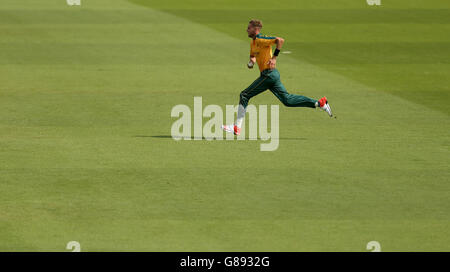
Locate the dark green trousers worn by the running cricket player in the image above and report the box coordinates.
[239,69,317,108]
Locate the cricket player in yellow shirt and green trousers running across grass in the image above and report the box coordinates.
[222,20,333,135]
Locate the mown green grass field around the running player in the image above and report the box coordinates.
[0,0,450,251]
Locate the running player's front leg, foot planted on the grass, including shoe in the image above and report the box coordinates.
[222,76,273,135]
